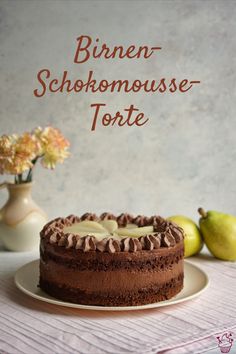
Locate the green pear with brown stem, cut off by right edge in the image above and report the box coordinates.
[198,208,236,261]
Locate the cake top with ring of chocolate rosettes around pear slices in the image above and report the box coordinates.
[41,213,184,253]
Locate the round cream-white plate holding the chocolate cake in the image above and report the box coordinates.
[15,260,209,311]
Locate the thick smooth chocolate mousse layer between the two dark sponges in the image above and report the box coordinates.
[40,261,183,294]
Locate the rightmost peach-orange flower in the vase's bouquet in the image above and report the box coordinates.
[33,127,70,169]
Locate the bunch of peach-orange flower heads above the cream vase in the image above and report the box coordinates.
[0,127,70,183]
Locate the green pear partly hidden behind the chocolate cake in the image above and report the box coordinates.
[168,215,203,258]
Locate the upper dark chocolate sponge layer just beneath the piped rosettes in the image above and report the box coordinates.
[40,242,184,270]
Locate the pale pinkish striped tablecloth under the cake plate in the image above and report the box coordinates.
[0,249,236,354]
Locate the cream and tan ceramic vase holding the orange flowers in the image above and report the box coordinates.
[0,183,47,251]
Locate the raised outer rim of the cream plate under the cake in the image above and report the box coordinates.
[14,259,210,311]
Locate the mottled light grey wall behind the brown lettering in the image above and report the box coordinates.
[0,0,236,218]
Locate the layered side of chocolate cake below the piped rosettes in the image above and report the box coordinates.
[40,243,184,306]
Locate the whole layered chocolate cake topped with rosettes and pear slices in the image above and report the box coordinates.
[39,213,184,306]
